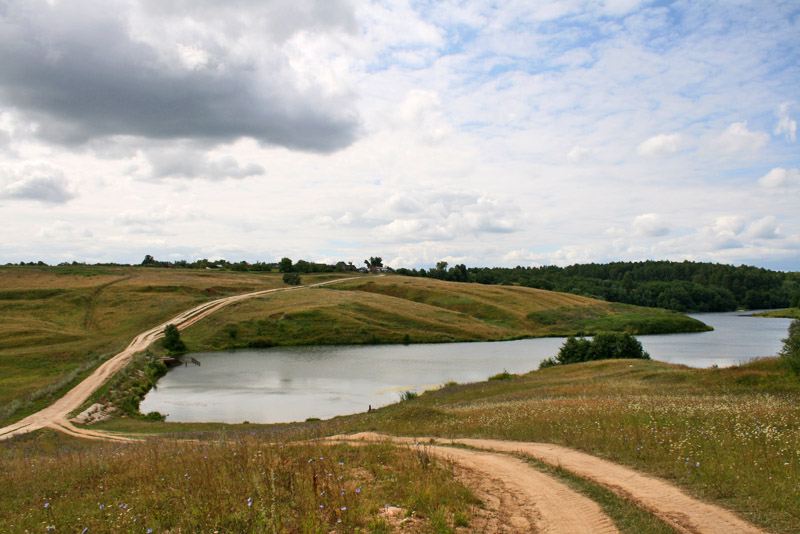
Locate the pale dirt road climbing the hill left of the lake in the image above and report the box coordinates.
[0,277,355,441]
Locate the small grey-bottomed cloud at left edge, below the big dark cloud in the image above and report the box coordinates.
[0,164,75,204]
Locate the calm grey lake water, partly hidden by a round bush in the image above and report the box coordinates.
[140,312,791,423]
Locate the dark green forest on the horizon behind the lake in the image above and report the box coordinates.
[395,261,800,312]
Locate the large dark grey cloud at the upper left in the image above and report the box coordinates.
[0,0,359,152]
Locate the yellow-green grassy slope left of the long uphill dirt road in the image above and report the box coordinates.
[0,266,348,422]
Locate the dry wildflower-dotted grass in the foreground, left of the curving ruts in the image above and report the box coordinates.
[0,433,477,533]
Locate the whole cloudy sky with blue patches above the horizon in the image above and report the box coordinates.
[0,0,800,271]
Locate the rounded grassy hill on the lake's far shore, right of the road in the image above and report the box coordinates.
[183,276,707,351]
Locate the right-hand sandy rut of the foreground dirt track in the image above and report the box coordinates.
[330,432,767,534]
